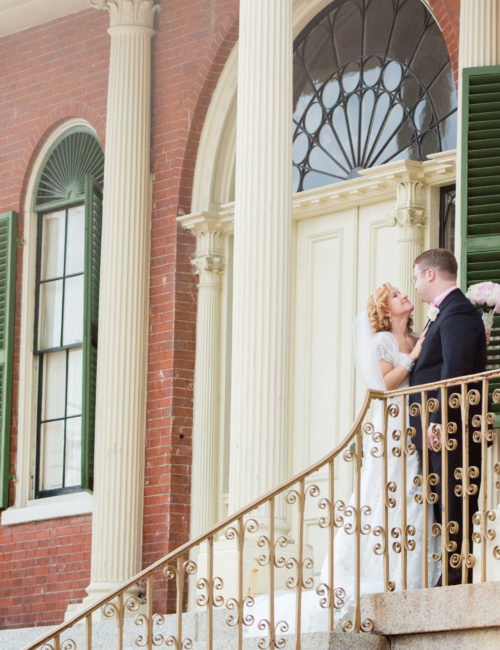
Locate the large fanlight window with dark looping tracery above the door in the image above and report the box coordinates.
[293,0,457,191]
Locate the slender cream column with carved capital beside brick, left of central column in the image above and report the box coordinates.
[191,217,224,537]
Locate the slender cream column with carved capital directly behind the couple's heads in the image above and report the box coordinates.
[396,179,427,329]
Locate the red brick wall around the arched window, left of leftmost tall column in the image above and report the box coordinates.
[0,10,109,627]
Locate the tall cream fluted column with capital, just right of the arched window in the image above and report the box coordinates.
[87,0,156,597]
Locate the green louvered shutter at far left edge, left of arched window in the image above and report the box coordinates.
[0,212,17,508]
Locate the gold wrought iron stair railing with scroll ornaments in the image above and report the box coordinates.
[26,369,500,650]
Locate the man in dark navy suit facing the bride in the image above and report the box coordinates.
[410,248,486,585]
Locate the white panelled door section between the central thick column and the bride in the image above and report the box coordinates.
[293,209,357,573]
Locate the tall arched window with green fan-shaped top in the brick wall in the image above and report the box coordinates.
[34,127,104,497]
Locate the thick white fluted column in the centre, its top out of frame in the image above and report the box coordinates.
[229,0,292,514]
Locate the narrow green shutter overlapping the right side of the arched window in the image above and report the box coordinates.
[82,176,102,490]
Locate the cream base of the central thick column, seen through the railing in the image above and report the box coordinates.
[195,538,314,604]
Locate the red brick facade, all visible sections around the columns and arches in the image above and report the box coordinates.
[0,0,459,627]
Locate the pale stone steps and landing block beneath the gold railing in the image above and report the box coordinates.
[5,582,500,650]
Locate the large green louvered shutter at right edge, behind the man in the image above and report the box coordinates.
[461,66,500,426]
